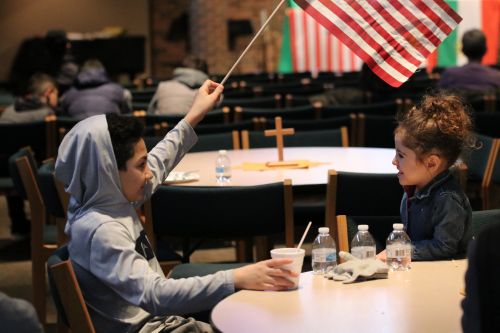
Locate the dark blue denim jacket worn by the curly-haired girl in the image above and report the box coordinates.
[401,170,472,260]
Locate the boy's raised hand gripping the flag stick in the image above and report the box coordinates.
[184,80,224,127]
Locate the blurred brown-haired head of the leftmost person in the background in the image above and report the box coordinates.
[23,73,59,108]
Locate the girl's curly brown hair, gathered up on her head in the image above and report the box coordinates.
[395,93,475,166]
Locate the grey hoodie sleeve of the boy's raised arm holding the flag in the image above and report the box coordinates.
[146,119,198,193]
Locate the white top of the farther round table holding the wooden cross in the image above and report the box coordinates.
[174,147,397,186]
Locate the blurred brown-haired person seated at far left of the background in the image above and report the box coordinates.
[0,73,59,124]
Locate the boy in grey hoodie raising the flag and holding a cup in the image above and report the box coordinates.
[55,81,298,333]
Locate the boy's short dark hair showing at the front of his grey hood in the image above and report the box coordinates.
[106,113,144,171]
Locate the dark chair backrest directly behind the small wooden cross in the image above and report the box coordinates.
[241,126,349,149]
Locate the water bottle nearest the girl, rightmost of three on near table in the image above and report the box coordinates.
[385,223,411,271]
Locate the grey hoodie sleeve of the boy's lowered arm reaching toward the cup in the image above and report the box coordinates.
[90,222,234,315]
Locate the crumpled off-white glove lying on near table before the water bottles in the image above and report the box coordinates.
[325,251,389,283]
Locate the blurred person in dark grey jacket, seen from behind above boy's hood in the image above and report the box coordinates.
[61,59,131,119]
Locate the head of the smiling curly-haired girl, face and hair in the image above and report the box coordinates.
[392,94,475,190]
